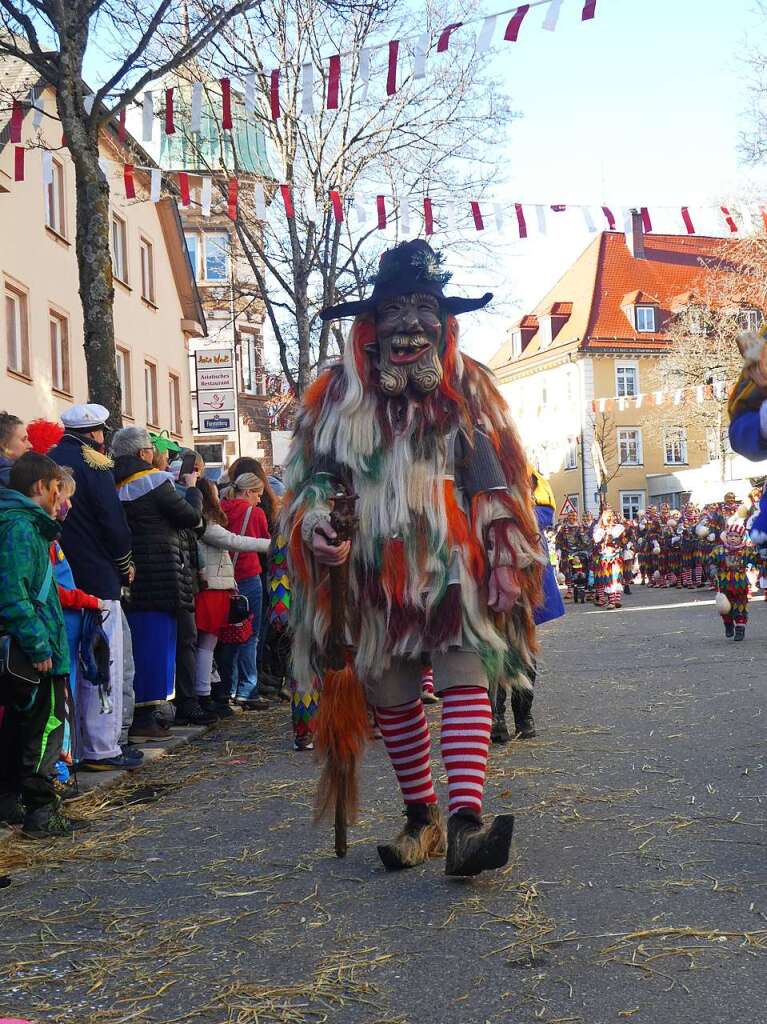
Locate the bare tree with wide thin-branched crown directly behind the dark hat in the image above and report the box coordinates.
[167,0,512,393]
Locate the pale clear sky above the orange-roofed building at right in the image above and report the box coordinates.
[445,0,767,358]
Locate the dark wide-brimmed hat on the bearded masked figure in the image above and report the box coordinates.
[319,239,493,321]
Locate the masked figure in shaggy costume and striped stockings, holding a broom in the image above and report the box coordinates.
[284,240,544,876]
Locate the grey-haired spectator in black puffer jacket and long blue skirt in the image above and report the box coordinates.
[112,427,204,735]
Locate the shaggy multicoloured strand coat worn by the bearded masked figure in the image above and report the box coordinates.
[284,315,544,686]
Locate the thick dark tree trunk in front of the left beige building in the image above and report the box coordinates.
[56,58,123,429]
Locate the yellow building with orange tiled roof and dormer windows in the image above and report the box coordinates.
[489,215,761,516]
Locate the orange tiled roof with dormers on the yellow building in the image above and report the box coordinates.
[491,231,745,370]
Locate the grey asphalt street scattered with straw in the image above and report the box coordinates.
[0,588,767,1024]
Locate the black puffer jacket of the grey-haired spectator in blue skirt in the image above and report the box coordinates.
[115,455,203,613]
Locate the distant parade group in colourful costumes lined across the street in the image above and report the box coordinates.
[553,487,767,640]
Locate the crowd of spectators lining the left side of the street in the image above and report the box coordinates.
[0,404,290,839]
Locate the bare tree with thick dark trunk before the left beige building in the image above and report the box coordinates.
[0,0,254,423]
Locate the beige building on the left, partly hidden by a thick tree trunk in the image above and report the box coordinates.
[0,60,205,443]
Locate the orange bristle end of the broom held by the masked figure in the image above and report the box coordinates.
[314,662,368,857]
